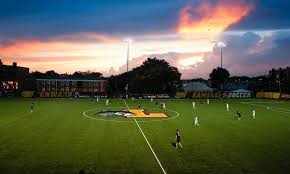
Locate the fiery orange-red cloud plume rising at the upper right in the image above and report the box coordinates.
[177,0,253,33]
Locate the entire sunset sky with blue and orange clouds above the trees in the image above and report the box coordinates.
[0,0,290,79]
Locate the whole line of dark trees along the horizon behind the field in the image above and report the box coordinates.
[29,57,290,94]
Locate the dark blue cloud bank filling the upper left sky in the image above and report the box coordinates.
[0,0,181,38]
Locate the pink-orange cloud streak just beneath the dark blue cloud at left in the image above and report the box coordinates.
[0,33,119,56]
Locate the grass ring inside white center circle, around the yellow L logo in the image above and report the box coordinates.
[82,107,179,123]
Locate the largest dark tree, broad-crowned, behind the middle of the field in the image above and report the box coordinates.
[109,57,181,94]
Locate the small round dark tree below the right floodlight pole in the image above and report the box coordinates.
[209,67,230,90]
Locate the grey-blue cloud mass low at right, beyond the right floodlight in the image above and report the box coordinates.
[218,32,290,75]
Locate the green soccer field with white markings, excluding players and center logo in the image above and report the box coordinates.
[0,99,290,174]
